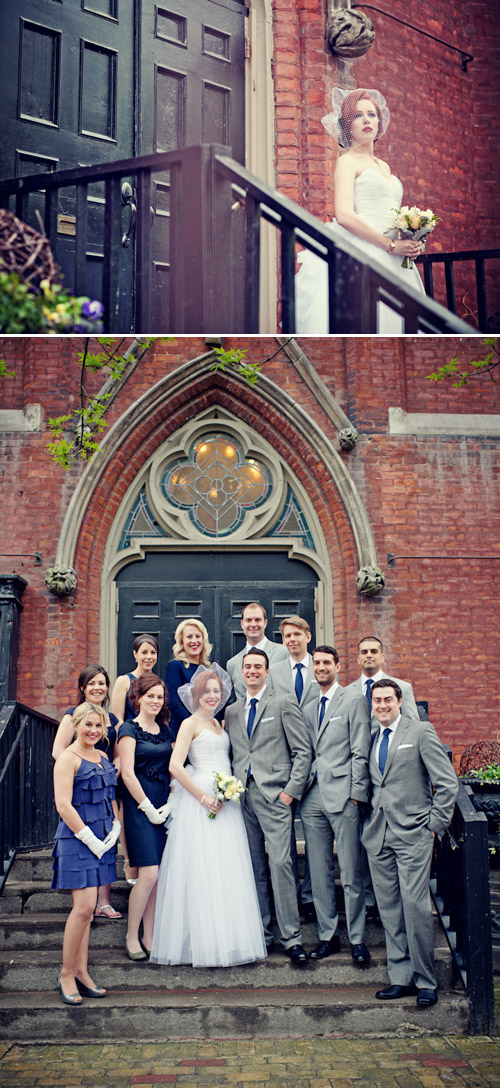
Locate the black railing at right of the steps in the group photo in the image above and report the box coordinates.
[430,783,495,1035]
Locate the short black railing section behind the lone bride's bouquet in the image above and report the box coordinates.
[418,249,500,333]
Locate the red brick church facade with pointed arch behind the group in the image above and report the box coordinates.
[0,337,500,757]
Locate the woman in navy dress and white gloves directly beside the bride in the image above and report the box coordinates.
[118,673,173,960]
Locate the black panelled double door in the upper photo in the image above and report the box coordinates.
[0,0,248,332]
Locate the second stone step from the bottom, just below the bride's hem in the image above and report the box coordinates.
[0,932,452,993]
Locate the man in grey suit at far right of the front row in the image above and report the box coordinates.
[362,679,459,1007]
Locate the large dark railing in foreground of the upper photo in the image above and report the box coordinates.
[0,146,475,334]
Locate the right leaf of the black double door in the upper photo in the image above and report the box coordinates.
[138,0,248,332]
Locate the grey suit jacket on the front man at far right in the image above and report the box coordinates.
[361,717,459,854]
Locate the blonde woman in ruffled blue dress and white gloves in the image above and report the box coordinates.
[52,703,120,1005]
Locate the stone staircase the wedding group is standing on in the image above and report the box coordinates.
[0,850,468,1042]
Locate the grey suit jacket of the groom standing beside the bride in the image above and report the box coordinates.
[225,688,312,802]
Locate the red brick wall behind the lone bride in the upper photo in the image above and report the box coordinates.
[274,0,500,317]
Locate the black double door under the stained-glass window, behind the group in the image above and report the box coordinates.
[116,552,317,676]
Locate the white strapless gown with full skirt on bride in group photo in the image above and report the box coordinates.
[151,729,267,967]
